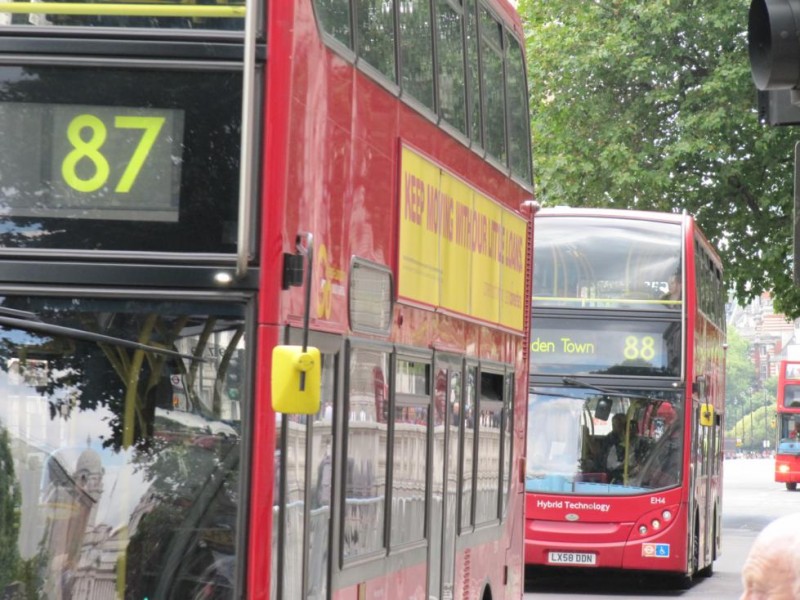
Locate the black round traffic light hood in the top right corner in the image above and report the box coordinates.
[747,0,800,91]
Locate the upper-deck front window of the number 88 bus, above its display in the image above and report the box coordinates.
[533,216,682,310]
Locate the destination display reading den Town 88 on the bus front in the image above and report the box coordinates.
[531,319,680,376]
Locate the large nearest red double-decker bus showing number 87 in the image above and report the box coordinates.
[0,0,532,600]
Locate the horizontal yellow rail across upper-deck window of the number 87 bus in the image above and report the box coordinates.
[0,0,244,17]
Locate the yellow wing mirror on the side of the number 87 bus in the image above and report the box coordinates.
[272,346,322,415]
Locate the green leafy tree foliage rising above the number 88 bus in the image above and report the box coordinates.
[519,0,800,317]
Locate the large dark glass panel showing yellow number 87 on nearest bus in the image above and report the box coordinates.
[0,64,242,253]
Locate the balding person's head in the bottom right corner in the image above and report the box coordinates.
[740,513,800,600]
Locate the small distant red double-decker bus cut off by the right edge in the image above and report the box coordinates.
[775,360,800,491]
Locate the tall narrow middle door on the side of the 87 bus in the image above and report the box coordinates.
[428,361,463,600]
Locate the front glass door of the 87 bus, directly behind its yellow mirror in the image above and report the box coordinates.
[272,331,341,600]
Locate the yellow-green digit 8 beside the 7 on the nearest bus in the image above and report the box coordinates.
[61,115,109,192]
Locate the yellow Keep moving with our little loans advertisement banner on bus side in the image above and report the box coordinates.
[398,146,527,332]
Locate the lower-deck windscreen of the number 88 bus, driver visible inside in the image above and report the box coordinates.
[525,387,684,495]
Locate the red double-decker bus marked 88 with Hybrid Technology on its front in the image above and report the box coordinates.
[525,208,725,584]
